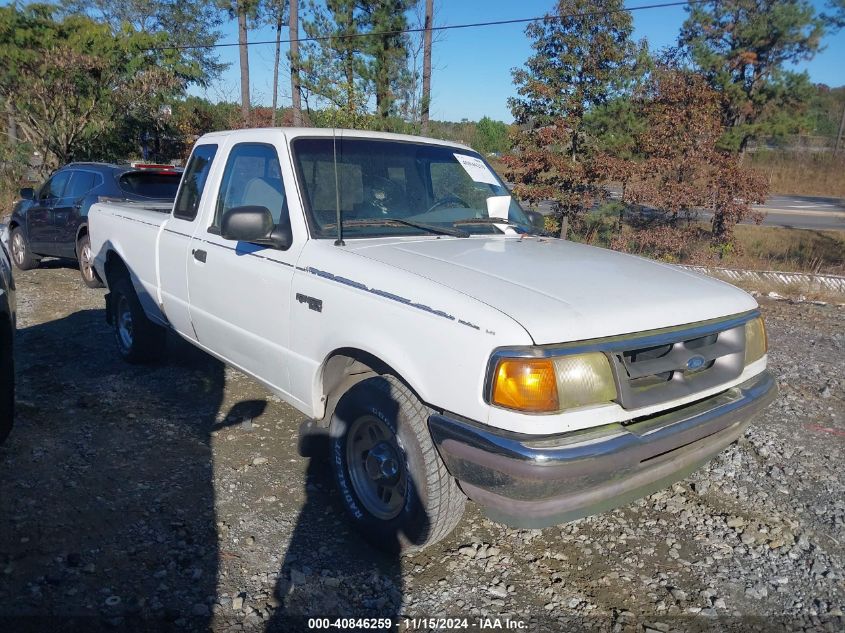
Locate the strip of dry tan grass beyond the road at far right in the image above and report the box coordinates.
[746,151,845,198]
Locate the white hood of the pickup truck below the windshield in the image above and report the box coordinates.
[347,236,757,345]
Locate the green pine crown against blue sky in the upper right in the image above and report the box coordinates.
[679,0,824,151]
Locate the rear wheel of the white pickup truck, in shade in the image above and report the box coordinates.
[109,275,167,364]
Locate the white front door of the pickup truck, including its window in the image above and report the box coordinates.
[188,135,304,393]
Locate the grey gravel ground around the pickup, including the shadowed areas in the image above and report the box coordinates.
[0,262,845,631]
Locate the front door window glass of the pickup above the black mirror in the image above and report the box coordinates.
[212,143,287,229]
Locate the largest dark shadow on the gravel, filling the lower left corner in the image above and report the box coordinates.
[0,310,244,631]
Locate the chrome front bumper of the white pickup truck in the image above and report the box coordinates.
[429,372,777,528]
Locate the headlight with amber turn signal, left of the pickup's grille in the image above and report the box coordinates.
[490,352,616,413]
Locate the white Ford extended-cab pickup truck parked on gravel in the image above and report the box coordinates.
[90,128,776,548]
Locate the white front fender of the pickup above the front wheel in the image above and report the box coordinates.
[290,242,531,421]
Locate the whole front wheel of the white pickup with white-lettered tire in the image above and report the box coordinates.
[330,375,466,552]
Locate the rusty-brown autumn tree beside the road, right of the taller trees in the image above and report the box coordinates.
[605,67,767,259]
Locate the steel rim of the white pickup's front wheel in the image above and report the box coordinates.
[346,415,408,521]
